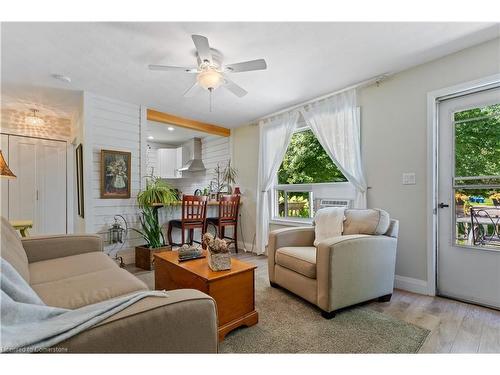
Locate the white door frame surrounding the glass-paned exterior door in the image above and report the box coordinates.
[427,73,500,296]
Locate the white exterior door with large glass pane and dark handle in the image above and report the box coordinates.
[437,88,500,308]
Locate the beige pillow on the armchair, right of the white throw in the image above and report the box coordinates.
[342,208,391,235]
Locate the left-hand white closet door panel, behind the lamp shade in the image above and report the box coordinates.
[9,136,38,234]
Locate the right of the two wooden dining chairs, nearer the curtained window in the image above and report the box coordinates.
[205,195,240,252]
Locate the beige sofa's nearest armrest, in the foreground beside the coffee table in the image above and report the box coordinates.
[56,289,218,353]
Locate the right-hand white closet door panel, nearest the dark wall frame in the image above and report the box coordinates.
[36,140,66,234]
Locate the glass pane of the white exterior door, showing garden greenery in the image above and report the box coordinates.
[453,104,500,250]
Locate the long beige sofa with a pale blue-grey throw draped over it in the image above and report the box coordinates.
[1,218,218,353]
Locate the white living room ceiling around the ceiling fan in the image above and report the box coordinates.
[1,22,499,127]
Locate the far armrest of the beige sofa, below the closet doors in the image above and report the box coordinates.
[21,234,102,263]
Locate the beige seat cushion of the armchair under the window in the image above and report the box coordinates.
[276,246,316,279]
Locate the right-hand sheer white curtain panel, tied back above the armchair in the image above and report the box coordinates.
[301,89,366,208]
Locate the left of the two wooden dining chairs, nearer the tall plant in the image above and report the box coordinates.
[167,195,208,246]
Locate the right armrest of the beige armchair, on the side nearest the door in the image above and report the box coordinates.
[316,234,397,312]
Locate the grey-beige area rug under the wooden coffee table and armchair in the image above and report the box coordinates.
[137,272,429,353]
